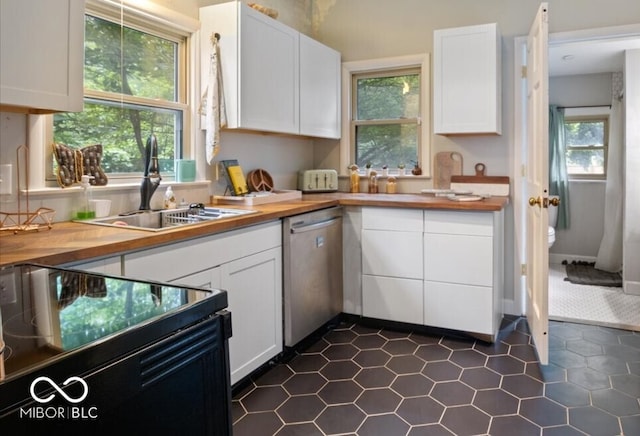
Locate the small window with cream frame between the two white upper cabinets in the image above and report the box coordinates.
[341,55,430,176]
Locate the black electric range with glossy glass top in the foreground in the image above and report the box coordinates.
[0,264,231,434]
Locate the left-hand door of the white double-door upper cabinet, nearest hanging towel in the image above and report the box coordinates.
[240,4,300,134]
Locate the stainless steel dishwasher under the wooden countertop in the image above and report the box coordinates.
[283,207,342,347]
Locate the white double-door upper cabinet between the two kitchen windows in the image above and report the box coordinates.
[200,2,340,138]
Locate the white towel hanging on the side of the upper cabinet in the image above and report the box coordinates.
[200,33,227,165]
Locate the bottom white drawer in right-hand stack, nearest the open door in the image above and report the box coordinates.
[424,281,494,334]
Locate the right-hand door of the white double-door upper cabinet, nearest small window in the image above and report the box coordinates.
[300,34,340,138]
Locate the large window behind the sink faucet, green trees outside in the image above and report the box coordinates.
[48,9,187,183]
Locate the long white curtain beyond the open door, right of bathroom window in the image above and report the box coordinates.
[595,73,624,272]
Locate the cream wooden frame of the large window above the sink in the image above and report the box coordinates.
[41,0,200,187]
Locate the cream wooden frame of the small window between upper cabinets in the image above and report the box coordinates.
[339,53,431,177]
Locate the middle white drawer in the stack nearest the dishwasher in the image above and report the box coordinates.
[362,230,423,280]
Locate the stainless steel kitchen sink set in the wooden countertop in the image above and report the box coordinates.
[77,207,258,232]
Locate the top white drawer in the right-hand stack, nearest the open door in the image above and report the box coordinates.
[424,210,493,236]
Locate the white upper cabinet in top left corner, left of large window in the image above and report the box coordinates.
[0,0,84,113]
